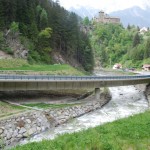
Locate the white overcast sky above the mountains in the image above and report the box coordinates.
[59,0,150,13]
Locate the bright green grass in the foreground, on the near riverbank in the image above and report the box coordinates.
[13,111,150,150]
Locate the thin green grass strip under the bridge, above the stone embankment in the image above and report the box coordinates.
[23,103,78,109]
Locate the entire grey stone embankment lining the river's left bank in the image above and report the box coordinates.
[0,91,111,147]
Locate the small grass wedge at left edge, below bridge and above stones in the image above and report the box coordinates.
[0,101,25,118]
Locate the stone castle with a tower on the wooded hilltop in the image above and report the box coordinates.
[94,11,120,23]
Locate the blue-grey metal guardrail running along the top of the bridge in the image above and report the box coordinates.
[0,75,150,81]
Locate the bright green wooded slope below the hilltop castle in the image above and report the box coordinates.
[90,23,150,68]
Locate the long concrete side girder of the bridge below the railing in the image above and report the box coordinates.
[0,78,150,91]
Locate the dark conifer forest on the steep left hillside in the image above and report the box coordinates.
[0,0,94,71]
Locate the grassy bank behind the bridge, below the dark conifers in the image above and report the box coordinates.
[0,59,84,75]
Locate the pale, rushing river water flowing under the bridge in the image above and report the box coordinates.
[22,83,148,144]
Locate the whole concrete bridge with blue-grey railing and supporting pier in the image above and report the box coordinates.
[0,75,150,97]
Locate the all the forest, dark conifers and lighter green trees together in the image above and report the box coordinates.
[0,0,150,71]
